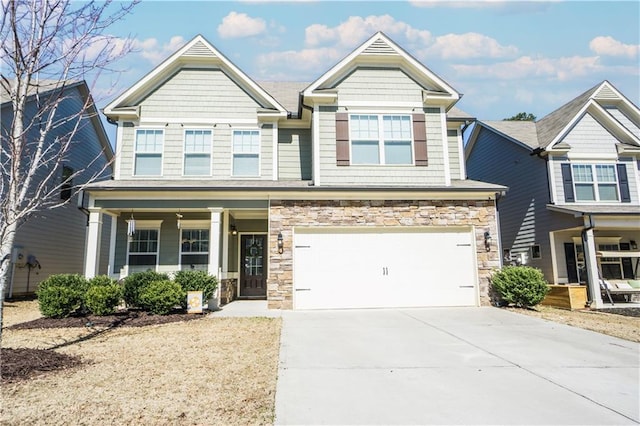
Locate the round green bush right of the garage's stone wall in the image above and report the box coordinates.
[491,266,549,307]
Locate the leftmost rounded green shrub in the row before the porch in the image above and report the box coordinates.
[36,274,89,318]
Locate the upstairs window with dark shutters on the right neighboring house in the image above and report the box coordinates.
[573,164,619,201]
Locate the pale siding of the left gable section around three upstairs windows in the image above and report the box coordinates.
[119,69,275,180]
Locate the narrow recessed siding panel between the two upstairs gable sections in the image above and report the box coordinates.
[278,129,312,180]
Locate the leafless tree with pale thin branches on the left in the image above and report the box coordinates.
[0,0,137,342]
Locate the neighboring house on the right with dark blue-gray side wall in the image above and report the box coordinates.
[465,81,640,305]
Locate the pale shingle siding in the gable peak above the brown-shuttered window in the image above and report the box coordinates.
[332,68,422,104]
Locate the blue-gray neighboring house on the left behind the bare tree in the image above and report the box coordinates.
[1,81,113,297]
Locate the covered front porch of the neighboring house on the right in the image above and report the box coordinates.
[550,206,640,309]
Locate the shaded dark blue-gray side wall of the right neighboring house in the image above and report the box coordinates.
[466,129,581,281]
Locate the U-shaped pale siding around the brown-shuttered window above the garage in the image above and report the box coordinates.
[319,107,445,185]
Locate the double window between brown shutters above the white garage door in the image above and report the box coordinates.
[349,114,413,164]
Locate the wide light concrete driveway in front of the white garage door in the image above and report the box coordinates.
[276,308,640,425]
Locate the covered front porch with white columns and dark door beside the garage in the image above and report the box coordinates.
[85,197,269,303]
